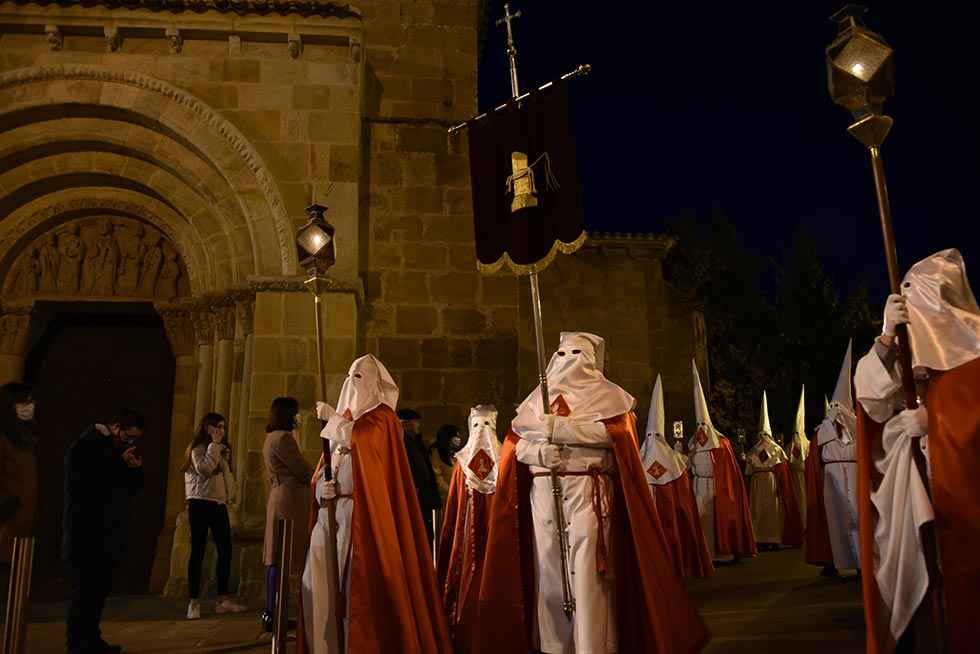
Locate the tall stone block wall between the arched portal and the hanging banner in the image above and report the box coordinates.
[359,1,518,436]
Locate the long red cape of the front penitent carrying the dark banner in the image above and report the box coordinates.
[474,412,708,654]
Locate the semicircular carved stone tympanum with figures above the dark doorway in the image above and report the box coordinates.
[4,217,189,300]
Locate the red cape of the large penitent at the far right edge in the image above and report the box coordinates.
[858,359,980,654]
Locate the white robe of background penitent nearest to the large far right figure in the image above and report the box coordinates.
[820,438,861,570]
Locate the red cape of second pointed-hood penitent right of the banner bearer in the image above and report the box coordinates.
[711,434,756,556]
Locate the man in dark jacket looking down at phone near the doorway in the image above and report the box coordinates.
[62,409,143,654]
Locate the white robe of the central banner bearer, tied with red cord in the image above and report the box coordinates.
[518,422,617,654]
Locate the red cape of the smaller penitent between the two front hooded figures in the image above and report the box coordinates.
[436,462,493,654]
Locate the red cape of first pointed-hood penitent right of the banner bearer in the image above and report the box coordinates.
[651,471,715,578]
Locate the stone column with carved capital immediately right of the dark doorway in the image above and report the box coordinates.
[151,304,197,597]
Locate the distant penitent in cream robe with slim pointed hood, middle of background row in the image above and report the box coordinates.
[745,391,803,547]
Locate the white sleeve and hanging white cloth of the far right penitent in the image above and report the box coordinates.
[854,349,935,637]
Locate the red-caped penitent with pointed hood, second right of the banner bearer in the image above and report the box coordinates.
[687,361,756,561]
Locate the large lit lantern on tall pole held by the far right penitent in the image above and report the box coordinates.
[826,4,945,652]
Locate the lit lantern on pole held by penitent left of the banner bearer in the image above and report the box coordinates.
[296,203,344,648]
